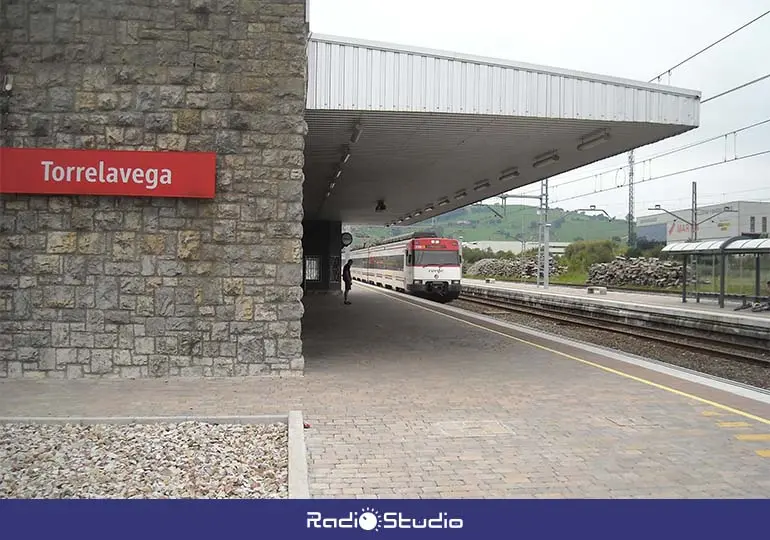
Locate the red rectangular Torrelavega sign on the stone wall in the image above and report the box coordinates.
[0,148,216,199]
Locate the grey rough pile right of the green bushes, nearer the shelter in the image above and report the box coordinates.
[586,257,680,288]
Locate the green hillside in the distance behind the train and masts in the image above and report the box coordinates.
[351,205,628,246]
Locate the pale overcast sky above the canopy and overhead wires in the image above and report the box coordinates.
[308,0,770,218]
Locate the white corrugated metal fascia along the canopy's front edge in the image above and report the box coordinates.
[307,37,700,126]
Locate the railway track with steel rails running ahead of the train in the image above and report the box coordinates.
[459,294,770,367]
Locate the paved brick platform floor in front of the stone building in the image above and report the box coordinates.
[0,283,770,498]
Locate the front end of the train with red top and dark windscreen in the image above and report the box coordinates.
[407,238,462,302]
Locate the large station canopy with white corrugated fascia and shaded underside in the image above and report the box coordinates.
[304,36,700,225]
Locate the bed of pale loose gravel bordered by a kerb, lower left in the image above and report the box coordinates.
[0,422,289,499]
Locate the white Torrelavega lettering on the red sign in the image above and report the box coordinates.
[40,161,171,189]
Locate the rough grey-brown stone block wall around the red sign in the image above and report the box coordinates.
[0,0,307,378]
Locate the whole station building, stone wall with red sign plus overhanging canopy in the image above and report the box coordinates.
[0,0,700,378]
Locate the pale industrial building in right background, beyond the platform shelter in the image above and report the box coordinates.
[636,201,770,243]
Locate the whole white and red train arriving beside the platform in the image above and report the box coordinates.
[349,232,462,302]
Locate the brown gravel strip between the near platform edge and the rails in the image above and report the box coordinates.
[452,300,770,390]
